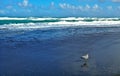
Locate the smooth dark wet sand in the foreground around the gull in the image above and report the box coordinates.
[0,28,120,76]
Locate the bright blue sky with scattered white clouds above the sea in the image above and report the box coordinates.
[0,0,120,17]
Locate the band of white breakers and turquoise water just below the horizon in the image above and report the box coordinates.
[0,17,120,30]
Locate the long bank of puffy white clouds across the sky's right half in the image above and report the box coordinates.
[59,3,120,12]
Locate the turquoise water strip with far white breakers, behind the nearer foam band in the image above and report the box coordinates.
[0,17,120,25]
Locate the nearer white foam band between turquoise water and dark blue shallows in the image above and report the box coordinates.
[0,21,120,30]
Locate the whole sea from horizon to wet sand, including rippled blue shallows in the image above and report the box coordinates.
[0,17,120,41]
